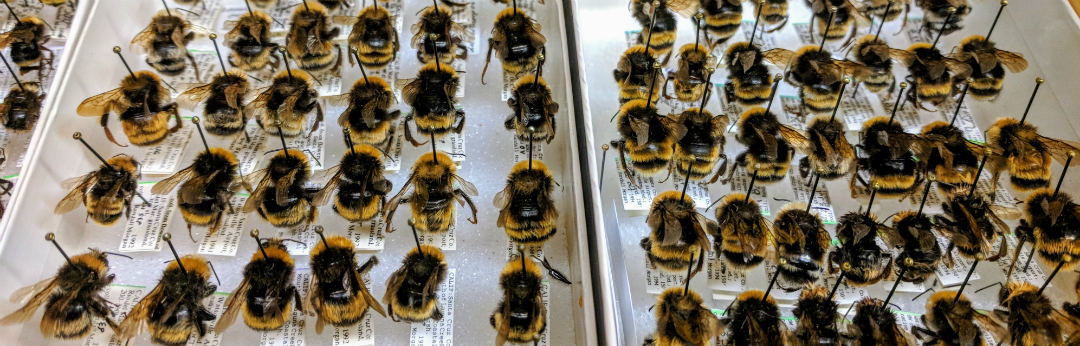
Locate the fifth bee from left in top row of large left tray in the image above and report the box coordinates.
[411,5,475,65]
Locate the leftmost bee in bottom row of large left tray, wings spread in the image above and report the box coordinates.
[0,232,118,340]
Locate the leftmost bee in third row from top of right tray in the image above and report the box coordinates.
[611,99,679,186]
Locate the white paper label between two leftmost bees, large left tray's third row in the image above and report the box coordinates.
[119,183,176,252]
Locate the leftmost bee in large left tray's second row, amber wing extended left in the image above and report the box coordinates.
[76,46,184,147]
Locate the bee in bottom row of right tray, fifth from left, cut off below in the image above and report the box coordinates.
[912,291,1002,346]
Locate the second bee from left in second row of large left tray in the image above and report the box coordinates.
[176,69,252,136]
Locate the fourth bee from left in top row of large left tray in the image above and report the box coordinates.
[335,4,401,69]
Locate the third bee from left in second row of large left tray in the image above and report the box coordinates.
[245,51,323,137]
